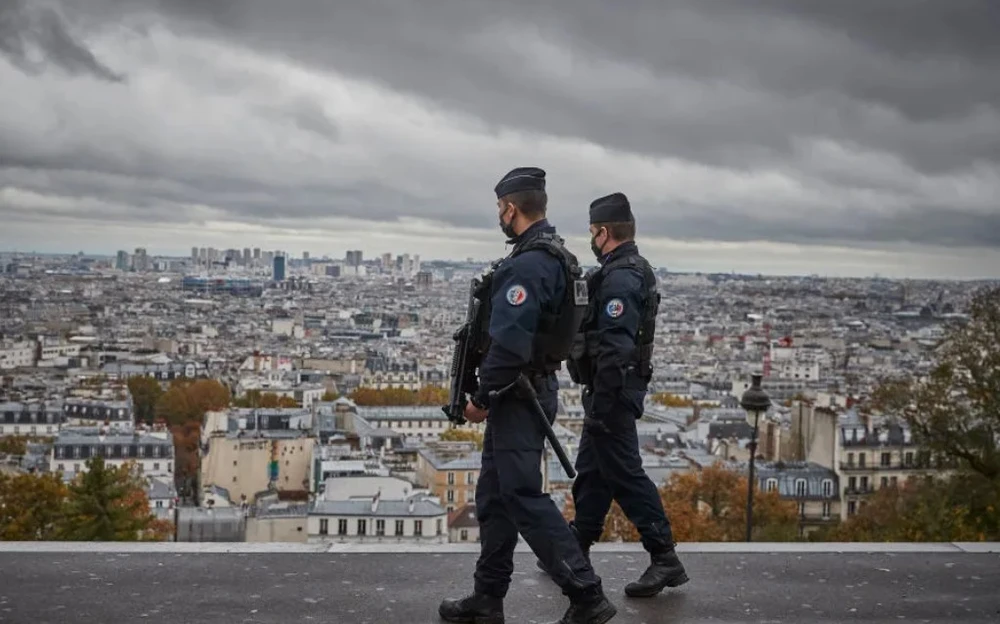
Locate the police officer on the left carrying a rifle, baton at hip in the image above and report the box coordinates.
[439,167,616,624]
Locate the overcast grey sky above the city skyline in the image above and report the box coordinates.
[0,0,1000,277]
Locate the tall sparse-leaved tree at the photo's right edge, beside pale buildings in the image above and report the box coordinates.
[871,287,1000,480]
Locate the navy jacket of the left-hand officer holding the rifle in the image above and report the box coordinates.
[475,219,566,405]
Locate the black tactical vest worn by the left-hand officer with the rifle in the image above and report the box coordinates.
[476,232,589,373]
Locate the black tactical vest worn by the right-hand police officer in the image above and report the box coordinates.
[567,254,660,386]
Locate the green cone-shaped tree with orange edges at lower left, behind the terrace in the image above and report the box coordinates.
[60,456,162,542]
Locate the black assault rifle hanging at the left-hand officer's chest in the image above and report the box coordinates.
[441,277,488,425]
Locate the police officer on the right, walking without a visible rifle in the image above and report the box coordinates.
[538,193,688,597]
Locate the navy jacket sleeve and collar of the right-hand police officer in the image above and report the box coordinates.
[590,241,645,417]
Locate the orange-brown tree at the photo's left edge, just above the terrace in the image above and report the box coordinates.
[0,473,69,541]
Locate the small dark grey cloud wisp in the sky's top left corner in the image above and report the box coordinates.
[0,0,125,82]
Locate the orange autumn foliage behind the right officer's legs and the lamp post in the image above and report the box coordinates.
[566,464,798,542]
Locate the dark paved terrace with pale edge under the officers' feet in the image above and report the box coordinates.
[0,542,1000,624]
